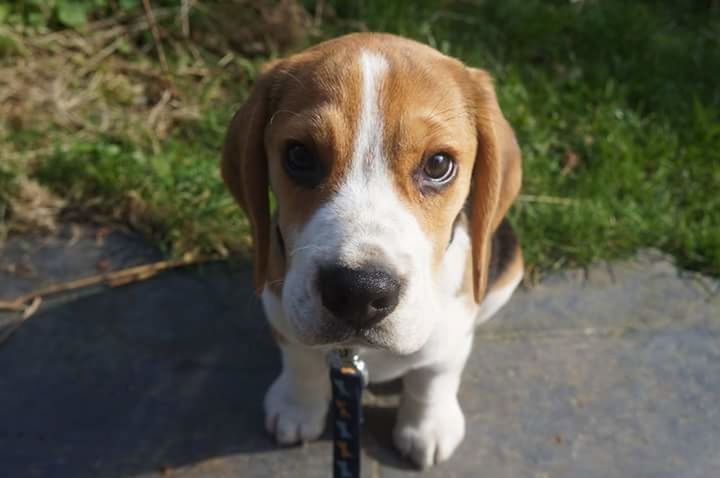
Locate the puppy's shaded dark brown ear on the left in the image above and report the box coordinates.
[221,64,275,293]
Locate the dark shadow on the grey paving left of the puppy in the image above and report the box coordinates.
[0,264,286,477]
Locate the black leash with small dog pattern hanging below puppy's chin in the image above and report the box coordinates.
[329,349,368,478]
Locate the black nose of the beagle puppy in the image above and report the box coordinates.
[318,266,401,329]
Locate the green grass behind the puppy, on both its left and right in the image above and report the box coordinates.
[0,0,720,275]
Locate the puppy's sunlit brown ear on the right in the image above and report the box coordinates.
[468,68,522,303]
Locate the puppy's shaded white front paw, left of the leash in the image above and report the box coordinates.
[265,375,328,445]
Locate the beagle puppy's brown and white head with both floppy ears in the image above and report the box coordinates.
[222,34,520,353]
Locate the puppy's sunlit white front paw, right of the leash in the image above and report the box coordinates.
[393,400,465,468]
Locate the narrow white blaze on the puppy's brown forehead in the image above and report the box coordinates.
[350,50,388,177]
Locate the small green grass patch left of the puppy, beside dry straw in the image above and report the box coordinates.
[35,121,248,255]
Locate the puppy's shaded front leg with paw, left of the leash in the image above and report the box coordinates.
[265,343,330,445]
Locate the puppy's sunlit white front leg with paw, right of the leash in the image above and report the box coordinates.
[394,336,472,468]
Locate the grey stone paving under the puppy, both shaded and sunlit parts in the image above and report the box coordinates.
[0,228,720,478]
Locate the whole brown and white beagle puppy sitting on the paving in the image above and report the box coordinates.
[221,33,523,467]
